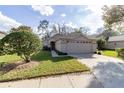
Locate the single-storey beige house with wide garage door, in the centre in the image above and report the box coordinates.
[43,32,97,53]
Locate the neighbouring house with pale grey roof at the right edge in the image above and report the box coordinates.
[106,35,124,49]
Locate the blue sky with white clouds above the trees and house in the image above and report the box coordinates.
[0,5,104,33]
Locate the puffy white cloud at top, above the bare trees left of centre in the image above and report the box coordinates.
[32,5,54,16]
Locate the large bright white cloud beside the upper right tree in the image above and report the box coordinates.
[80,5,103,33]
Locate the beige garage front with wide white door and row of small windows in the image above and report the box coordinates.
[56,38,97,53]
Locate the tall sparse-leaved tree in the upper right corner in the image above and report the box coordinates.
[102,5,124,31]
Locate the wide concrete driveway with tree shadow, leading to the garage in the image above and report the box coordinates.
[71,54,124,88]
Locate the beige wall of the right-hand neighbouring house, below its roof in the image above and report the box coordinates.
[106,41,124,49]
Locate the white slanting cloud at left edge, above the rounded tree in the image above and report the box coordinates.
[0,12,21,31]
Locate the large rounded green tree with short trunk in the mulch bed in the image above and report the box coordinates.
[1,31,41,62]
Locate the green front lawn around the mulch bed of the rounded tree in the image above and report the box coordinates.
[0,51,89,81]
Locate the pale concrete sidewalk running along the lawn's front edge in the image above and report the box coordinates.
[0,73,103,88]
